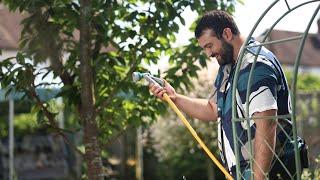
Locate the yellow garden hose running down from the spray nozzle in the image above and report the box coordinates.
[163,93,233,180]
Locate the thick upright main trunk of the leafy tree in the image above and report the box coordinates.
[79,0,104,180]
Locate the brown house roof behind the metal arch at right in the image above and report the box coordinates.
[260,30,320,67]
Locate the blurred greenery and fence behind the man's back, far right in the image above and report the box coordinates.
[286,72,320,177]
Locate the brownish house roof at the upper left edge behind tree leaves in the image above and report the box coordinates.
[0,5,24,50]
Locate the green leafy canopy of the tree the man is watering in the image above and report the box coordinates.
[0,0,239,178]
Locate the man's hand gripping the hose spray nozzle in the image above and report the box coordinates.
[149,80,177,101]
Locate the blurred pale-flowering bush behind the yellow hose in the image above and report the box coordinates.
[149,115,219,179]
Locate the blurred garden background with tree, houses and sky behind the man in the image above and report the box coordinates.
[0,0,320,180]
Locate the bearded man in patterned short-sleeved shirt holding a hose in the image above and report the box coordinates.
[150,10,308,179]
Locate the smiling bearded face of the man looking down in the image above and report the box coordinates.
[198,30,234,66]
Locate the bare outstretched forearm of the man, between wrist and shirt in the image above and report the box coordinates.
[174,94,217,121]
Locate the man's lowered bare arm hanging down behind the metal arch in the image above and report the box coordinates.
[253,110,277,180]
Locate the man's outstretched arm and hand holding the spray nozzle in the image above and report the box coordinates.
[149,82,217,121]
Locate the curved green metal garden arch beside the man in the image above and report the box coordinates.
[232,0,320,179]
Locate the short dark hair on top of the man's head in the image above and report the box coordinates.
[195,10,240,39]
